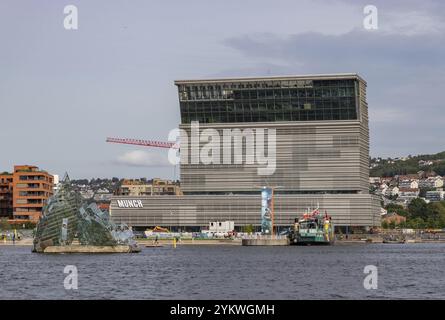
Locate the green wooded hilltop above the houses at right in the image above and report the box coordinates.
[369,151,445,177]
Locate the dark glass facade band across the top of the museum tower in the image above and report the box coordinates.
[178,79,358,124]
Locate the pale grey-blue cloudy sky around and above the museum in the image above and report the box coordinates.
[0,0,445,179]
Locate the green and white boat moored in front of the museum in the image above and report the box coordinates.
[289,208,335,245]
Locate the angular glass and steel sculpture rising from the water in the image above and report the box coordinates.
[33,175,137,252]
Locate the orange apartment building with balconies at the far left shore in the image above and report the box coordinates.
[0,165,54,222]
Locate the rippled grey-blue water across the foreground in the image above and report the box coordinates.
[0,244,445,299]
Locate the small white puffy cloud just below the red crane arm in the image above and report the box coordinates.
[114,150,171,167]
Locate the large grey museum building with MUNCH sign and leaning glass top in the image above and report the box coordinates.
[110,74,380,231]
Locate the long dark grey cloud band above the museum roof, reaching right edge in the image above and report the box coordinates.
[224,29,445,70]
